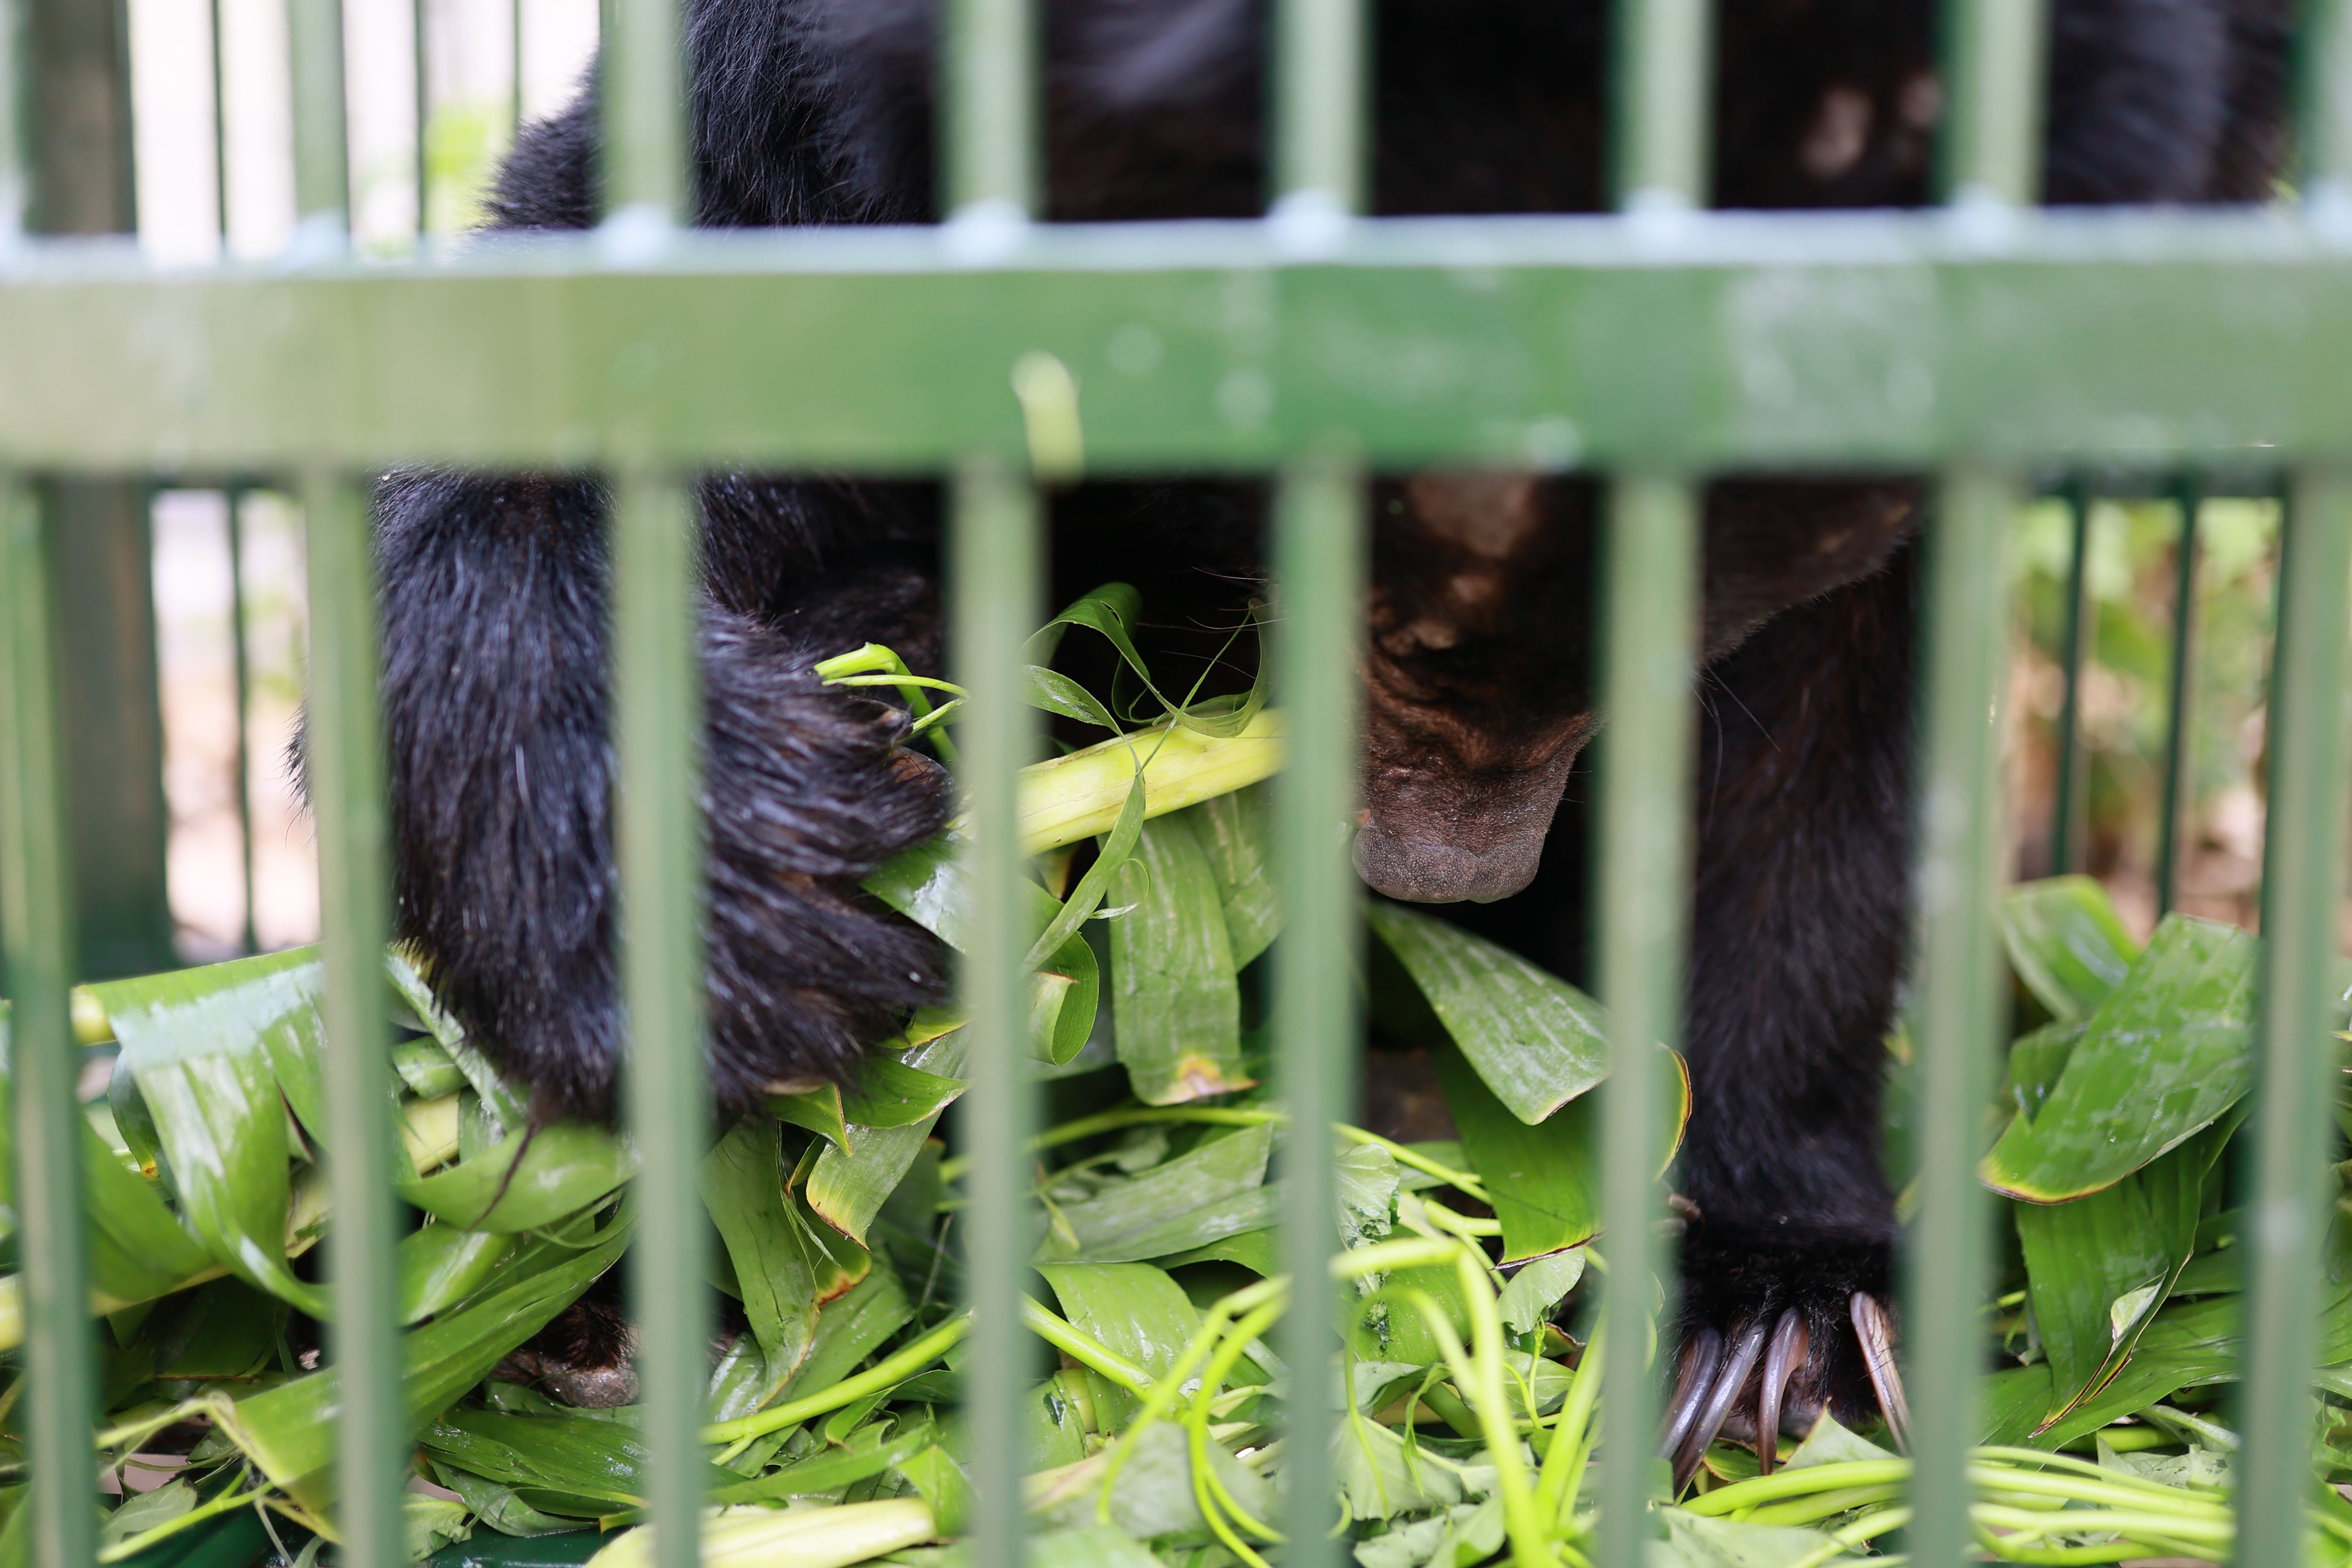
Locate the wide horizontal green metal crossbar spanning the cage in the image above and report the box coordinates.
[0,214,2352,475]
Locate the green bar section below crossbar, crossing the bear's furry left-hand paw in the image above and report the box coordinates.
[612,470,710,1568]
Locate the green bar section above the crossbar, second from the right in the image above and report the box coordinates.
[1938,0,2049,207]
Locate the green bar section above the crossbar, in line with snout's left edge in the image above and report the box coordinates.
[1272,0,1367,214]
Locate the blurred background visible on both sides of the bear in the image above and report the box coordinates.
[78,0,2296,976]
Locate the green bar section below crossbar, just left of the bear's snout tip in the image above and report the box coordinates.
[1272,451,1369,1568]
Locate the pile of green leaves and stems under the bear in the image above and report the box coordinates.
[0,595,2352,1568]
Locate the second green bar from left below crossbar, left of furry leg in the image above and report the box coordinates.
[303,472,409,1568]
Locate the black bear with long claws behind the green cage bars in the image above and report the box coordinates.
[379,0,2286,1457]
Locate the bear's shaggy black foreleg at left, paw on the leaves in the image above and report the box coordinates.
[379,475,948,1122]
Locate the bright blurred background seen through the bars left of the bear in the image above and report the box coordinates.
[101,0,597,976]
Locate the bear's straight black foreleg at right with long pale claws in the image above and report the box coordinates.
[1665,548,1915,1488]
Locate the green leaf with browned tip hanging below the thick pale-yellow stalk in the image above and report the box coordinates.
[1110,813,1251,1105]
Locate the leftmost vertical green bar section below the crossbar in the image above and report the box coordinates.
[0,470,99,1566]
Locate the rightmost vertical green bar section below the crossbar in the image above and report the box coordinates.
[2237,470,2352,1568]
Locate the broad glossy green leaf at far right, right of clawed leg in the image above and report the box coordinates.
[1983,915,2253,1203]
